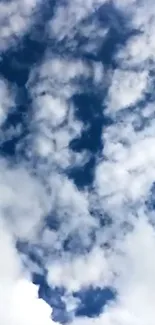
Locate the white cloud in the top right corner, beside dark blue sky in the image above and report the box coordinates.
[116,0,155,69]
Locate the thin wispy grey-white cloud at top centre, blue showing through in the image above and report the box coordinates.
[47,0,109,59]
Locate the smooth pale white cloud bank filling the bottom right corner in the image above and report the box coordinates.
[70,217,155,325]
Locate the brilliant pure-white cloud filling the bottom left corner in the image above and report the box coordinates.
[0,214,56,325]
